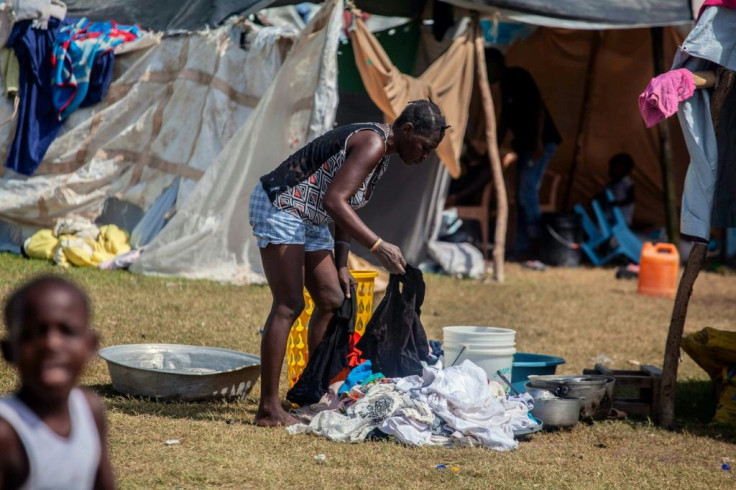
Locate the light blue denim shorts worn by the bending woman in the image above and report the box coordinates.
[248,182,335,252]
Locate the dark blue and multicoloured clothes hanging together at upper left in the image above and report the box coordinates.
[0,0,145,175]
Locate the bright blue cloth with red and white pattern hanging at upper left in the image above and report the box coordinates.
[51,19,142,120]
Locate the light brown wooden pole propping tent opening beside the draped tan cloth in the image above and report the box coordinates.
[473,19,509,282]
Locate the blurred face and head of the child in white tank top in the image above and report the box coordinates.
[1,285,97,398]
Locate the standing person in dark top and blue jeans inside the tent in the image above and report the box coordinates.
[486,49,562,269]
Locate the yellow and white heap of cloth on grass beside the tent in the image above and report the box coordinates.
[23,219,137,269]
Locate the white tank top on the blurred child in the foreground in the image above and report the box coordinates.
[0,388,101,490]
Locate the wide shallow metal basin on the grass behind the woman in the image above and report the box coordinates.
[100,344,261,401]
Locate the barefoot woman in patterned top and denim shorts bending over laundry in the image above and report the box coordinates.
[249,100,448,426]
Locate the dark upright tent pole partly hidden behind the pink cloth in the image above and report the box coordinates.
[650,27,680,245]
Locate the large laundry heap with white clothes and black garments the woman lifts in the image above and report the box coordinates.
[287,266,540,451]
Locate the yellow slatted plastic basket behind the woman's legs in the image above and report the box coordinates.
[286,271,378,388]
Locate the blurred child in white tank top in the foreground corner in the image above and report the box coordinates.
[0,276,115,489]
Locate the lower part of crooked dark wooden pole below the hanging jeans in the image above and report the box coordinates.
[659,242,708,427]
